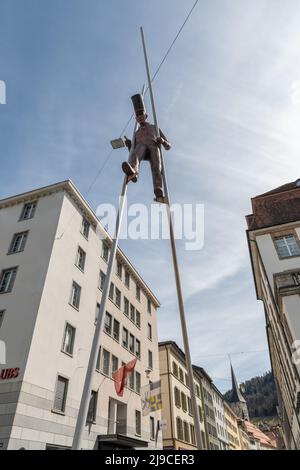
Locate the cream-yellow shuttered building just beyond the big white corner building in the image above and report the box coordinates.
[159,341,207,450]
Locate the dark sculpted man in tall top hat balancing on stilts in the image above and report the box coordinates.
[122,94,171,203]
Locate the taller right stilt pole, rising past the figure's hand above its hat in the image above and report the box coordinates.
[141,27,203,450]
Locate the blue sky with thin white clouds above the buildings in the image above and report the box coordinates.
[0,0,300,391]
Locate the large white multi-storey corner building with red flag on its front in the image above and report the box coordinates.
[0,181,162,449]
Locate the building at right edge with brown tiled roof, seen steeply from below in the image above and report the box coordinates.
[247,180,300,450]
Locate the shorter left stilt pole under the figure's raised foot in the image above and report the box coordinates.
[72,91,145,450]
